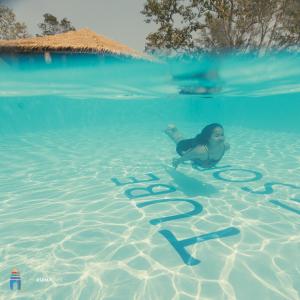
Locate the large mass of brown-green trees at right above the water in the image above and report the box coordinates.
[141,0,300,52]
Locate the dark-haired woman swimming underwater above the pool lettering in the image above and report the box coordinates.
[165,123,230,168]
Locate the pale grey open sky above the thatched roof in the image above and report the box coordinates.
[0,0,156,51]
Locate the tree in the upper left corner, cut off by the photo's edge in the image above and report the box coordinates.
[0,5,29,40]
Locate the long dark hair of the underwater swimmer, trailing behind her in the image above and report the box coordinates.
[176,123,223,155]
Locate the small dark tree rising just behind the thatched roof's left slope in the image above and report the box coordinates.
[38,13,75,36]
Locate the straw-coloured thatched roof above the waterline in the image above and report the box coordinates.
[0,28,145,57]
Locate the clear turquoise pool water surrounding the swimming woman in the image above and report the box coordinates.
[0,54,300,300]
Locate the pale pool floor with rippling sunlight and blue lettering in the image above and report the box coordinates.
[0,124,300,300]
